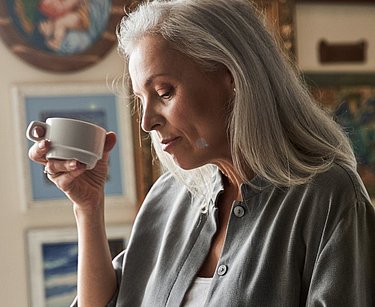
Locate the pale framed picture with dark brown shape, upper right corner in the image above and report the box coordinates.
[295,0,375,73]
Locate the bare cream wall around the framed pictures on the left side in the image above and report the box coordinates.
[0,40,134,307]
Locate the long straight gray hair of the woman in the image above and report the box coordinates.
[118,0,356,200]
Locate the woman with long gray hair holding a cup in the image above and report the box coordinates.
[30,0,375,307]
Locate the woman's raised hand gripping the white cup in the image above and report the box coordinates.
[29,127,116,211]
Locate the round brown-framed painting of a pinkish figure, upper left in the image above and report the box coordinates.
[0,0,133,72]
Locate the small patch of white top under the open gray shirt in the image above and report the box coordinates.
[182,277,212,307]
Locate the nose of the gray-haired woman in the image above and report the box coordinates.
[141,100,165,132]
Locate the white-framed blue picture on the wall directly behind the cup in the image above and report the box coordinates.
[13,82,136,209]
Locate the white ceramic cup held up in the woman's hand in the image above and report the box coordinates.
[26,117,106,169]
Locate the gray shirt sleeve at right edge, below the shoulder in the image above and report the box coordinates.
[306,202,375,307]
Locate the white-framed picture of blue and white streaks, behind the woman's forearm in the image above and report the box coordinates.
[27,226,131,307]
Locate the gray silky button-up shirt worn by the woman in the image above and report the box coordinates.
[76,164,375,307]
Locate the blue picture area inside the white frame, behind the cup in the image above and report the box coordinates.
[25,94,125,201]
